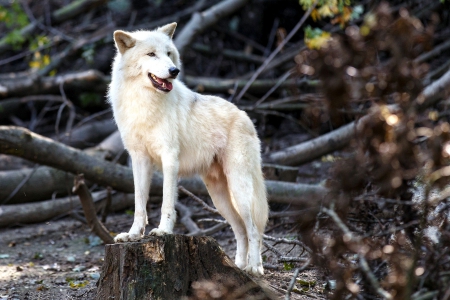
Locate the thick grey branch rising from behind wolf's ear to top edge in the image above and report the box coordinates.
[174,0,248,57]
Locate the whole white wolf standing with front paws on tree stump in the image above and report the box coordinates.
[108,23,268,275]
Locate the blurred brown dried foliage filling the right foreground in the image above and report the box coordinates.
[297,3,450,299]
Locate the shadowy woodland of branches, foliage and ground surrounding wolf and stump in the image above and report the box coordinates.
[0,0,450,300]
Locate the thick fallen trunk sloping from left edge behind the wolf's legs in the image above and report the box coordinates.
[0,126,328,207]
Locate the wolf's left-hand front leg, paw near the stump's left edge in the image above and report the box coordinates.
[114,151,153,243]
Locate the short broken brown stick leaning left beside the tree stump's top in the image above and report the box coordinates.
[72,174,114,244]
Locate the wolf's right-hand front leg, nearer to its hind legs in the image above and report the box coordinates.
[150,153,179,236]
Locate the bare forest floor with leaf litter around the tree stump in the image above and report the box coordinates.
[0,214,323,300]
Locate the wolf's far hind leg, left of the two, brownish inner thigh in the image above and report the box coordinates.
[203,163,248,269]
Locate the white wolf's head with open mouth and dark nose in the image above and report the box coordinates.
[114,23,181,93]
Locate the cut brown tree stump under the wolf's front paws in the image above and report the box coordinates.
[96,235,272,300]
